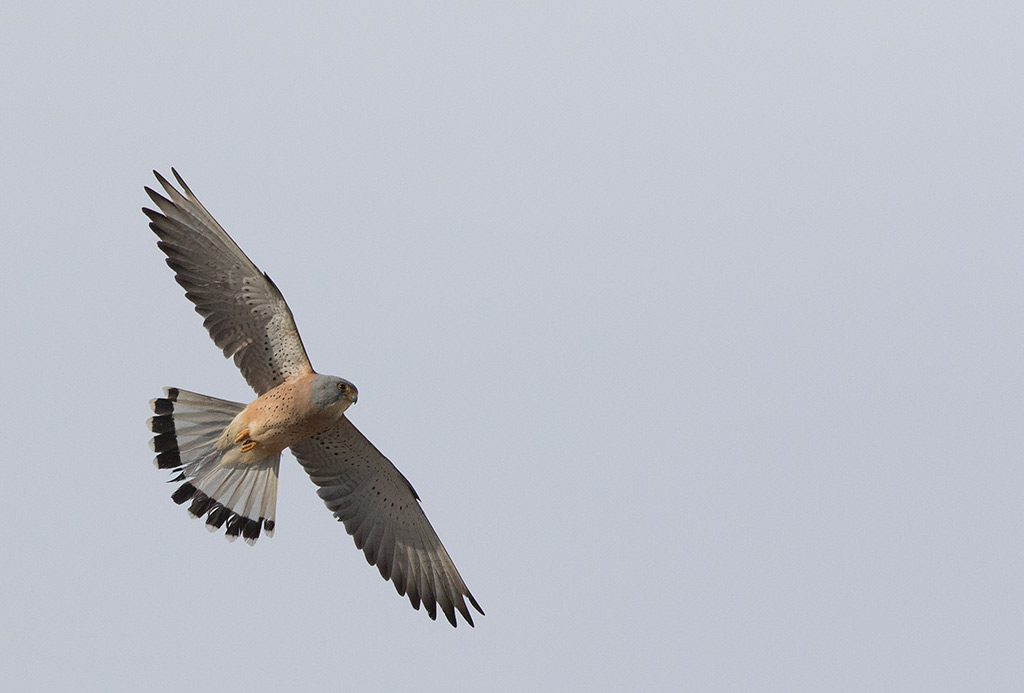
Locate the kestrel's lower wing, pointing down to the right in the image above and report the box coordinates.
[292,418,483,625]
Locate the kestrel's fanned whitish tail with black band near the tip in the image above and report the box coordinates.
[148,388,281,544]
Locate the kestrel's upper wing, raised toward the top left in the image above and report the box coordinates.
[142,169,312,394]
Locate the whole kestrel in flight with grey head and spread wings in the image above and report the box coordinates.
[142,169,483,625]
